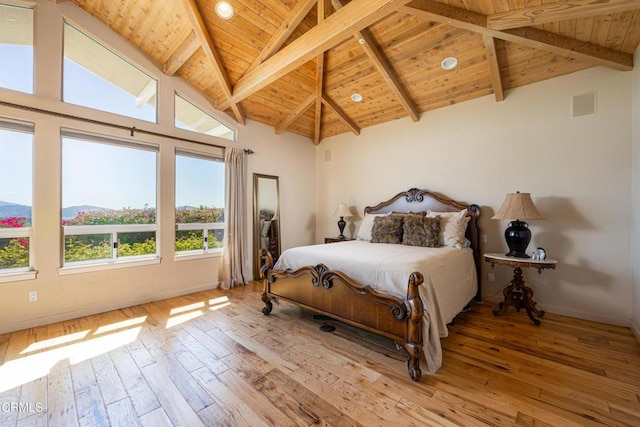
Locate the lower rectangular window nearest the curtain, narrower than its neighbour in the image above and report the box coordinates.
[176,151,224,254]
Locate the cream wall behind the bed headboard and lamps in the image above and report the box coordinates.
[316,68,632,325]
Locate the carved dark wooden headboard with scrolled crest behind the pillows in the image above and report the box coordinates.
[364,188,482,302]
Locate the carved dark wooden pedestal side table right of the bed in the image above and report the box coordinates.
[484,253,558,326]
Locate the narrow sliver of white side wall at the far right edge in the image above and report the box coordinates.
[631,48,640,340]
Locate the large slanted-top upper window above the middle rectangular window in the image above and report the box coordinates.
[62,22,157,122]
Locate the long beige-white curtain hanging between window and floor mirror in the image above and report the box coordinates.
[221,148,247,289]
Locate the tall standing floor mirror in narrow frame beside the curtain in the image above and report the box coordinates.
[253,173,280,279]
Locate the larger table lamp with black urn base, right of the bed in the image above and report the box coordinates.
[491,191,546,258]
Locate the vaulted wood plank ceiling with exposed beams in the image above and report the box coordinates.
[73,0,640,144]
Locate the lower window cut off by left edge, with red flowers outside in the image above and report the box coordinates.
[0,121,33,274]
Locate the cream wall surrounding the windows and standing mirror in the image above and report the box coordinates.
[0,0,315,333]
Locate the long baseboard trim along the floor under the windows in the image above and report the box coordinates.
[0,282,220,334]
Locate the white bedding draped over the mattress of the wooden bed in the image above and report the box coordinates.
[275,240,478,373]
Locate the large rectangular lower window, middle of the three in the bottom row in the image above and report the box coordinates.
[62,131,158,265]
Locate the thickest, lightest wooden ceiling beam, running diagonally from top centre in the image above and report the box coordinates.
[226,0,416,108]
